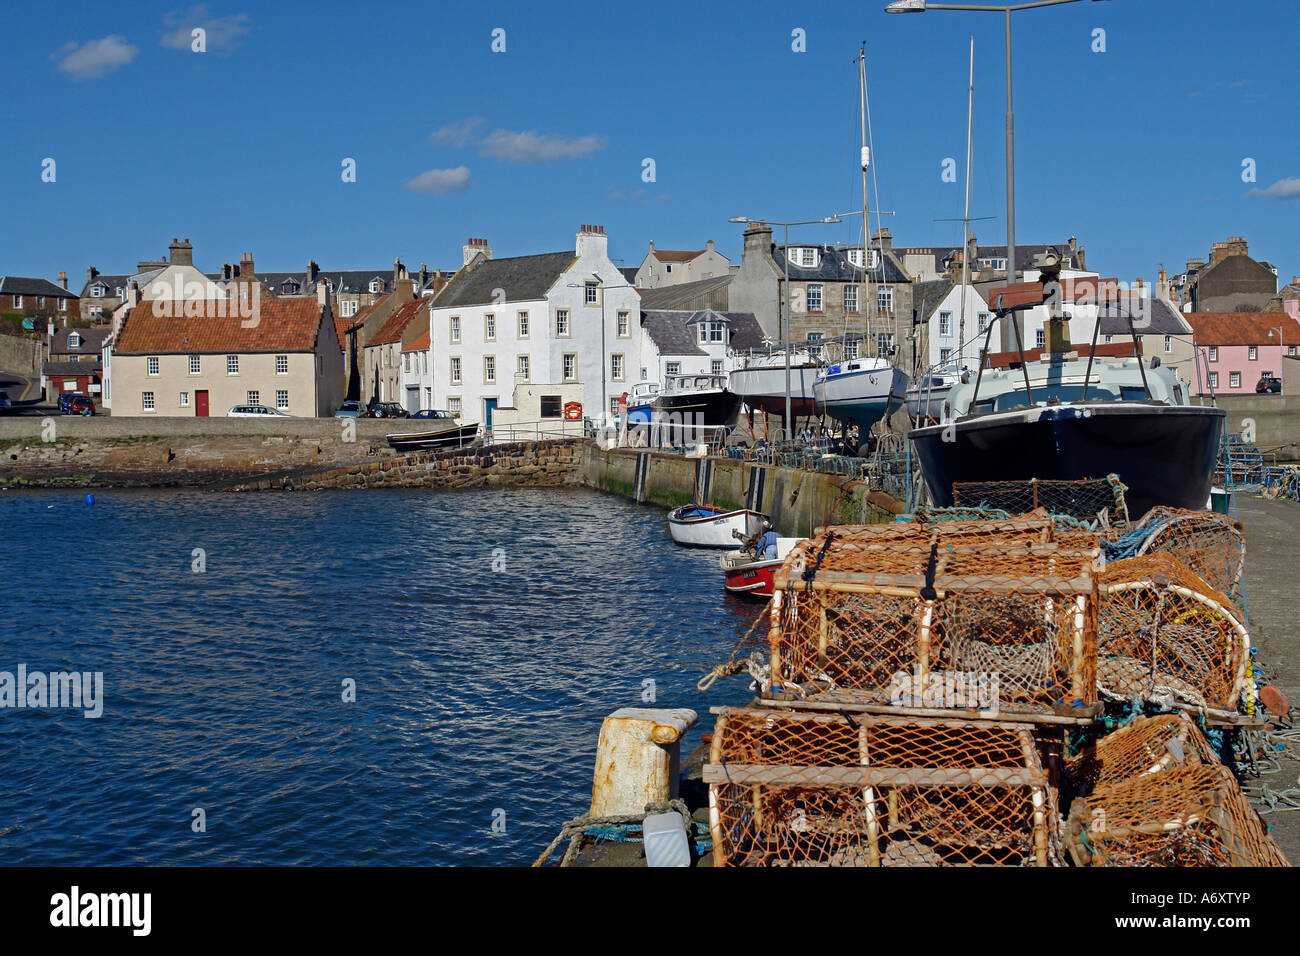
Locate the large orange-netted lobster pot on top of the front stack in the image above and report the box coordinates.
[768,523,1100,711]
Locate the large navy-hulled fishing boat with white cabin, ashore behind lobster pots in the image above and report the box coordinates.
[910,265,1225,518]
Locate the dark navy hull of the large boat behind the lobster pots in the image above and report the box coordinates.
[909,402,1225,520]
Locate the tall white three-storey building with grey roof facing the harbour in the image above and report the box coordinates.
[429,225,649,428]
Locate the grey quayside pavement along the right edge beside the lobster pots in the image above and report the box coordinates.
[1236,494,1300,865]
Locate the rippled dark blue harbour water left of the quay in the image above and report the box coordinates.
[0,489,758,865]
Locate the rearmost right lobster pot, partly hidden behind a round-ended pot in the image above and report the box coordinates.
[1135,506,1245,607]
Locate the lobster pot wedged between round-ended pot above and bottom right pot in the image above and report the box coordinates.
[1065,714,1219,792]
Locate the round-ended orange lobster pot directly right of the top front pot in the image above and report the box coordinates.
[1097,554,1251,713]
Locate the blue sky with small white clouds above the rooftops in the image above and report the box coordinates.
[0,0,1300,287]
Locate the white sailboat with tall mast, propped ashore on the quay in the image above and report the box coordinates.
[813,47,907,438]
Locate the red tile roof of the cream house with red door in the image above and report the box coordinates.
[113,297,321,355]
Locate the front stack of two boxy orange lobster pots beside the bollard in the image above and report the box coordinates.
[705,514,1102,866]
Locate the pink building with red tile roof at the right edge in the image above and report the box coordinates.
[1183,312,1300,395]
